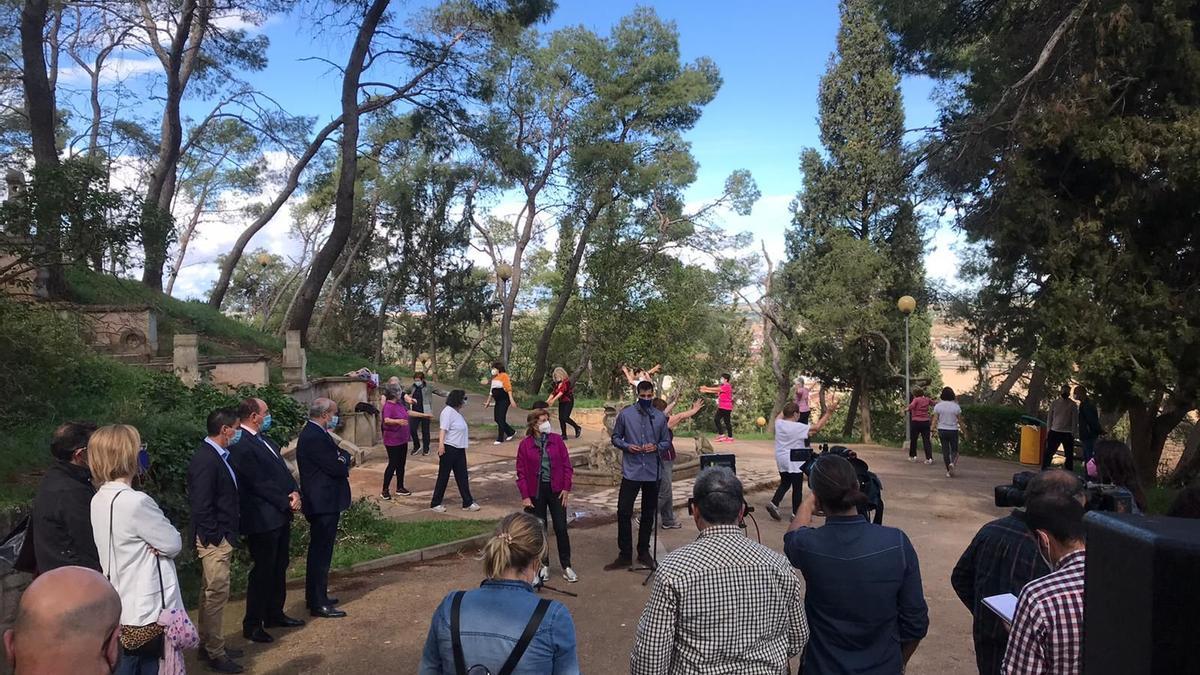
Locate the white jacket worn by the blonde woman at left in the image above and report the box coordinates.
[91,480,184,626]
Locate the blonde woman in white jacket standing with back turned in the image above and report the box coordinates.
[86,424,194,675]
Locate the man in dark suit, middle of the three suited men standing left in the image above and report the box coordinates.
[229,399,304,643]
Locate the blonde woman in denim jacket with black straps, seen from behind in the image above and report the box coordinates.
[420,513,580,675]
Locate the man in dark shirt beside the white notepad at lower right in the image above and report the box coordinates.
[950,470,1084,675]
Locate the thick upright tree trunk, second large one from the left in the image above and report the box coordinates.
[142,0,211,291]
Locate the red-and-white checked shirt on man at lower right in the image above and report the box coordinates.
[1004,550,1087,675]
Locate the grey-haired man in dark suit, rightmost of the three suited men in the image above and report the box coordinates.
[296,399,350,619]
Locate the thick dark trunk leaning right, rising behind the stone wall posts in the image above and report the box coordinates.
[290,0,390,344]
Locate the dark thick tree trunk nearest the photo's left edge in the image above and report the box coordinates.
[20,0,66,298]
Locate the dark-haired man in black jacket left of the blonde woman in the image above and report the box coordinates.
[26,422,100,573]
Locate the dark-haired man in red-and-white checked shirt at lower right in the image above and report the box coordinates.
[1004,485,1087,675]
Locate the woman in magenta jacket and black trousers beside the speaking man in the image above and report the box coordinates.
[517,410,580,584]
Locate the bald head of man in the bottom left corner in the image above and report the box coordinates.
[4,567,121,675]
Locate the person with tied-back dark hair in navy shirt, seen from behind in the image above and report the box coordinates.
[784,455,929,675]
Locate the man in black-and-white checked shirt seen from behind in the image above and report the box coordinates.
[630,467,809,675]
